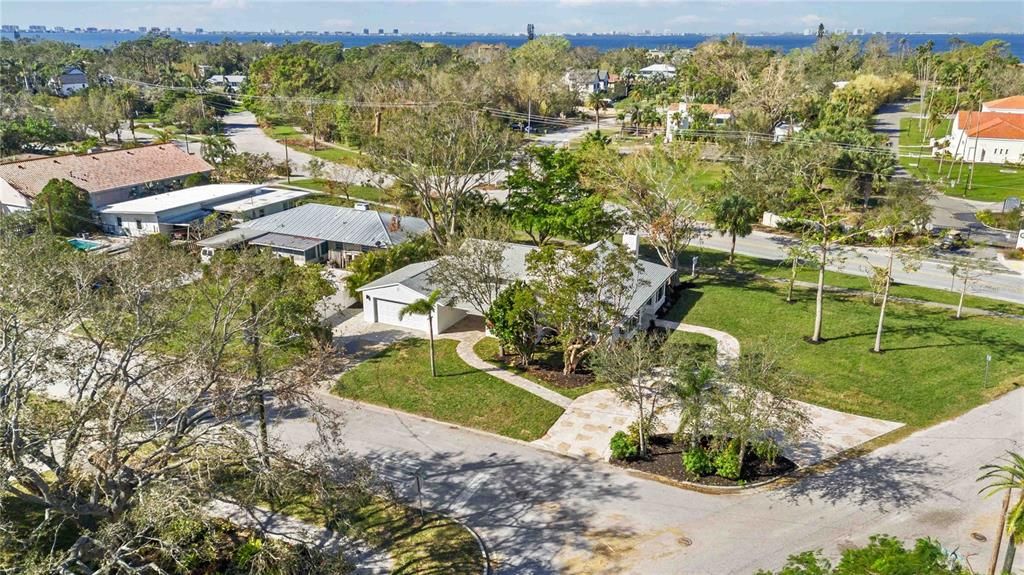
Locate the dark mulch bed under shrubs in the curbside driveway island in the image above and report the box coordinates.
[611,435,797,487]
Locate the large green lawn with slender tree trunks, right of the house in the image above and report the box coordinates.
[669,277,1024,429]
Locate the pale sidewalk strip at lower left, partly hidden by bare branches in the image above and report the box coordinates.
[207,499,394,575]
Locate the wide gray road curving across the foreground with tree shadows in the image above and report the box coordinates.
[273,390,1024,575]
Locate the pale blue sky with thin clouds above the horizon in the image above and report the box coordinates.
[0,0,1024,34]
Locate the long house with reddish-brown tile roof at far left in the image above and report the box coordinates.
[0,144,213,213]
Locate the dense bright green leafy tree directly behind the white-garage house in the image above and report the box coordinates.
[505,147,618,246]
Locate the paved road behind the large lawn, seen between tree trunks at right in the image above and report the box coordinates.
[696,226,1024,304]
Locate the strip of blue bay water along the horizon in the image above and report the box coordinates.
[6,32,1024,59]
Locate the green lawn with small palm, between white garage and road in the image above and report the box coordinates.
[334,339,562,441]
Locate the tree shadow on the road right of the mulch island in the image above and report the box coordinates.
[773,454,946,513]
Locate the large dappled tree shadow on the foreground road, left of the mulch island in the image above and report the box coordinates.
[354,450,636,573]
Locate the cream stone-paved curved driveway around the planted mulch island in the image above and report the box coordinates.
[534,319,903,467]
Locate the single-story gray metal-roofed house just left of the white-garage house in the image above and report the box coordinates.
[198,204,428,268]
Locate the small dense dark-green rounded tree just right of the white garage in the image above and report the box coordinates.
[484,280,541,367]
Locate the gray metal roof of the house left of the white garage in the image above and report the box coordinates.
[239,204,427,248]
